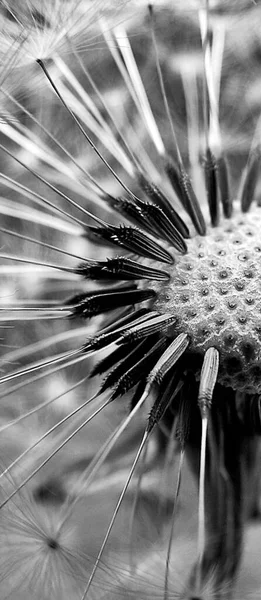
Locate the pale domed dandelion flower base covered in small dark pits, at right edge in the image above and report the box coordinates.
[154,207,261,393]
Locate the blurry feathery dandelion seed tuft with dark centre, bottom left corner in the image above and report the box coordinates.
[0,482,88,600]
